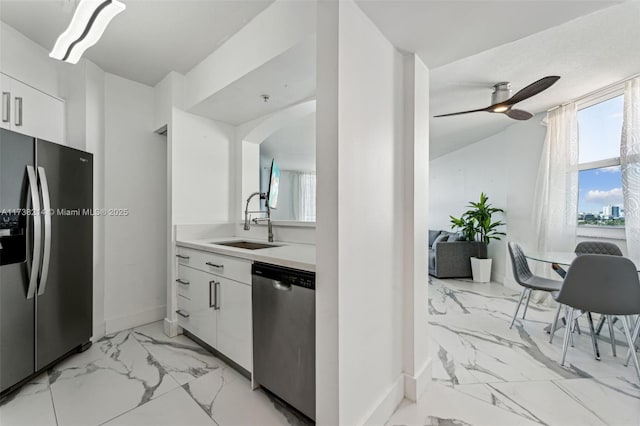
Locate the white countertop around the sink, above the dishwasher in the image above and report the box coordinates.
[176,237,316,272]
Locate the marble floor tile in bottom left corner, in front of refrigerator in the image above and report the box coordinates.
[0,373,57,426]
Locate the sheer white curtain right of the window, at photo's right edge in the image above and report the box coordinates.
[620,77,640,265]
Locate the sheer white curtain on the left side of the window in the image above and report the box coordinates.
[533,103,578,278]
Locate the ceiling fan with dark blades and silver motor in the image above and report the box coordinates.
[434,75,560,120]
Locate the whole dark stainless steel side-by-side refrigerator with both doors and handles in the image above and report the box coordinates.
[0,129,93,395]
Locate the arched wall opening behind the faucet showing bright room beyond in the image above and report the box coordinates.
[260,112,316,222]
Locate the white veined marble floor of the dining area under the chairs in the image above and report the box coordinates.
[389,279,640,426]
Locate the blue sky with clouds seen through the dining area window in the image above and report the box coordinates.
[578,96,623,213]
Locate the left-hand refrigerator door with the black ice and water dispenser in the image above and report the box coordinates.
[0,129,37,391]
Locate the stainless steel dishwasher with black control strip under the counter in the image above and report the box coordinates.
[252,263,316,420]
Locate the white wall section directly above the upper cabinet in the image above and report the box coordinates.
[0,22,59,96]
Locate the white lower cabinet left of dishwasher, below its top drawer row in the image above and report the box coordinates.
[175,252,252,371]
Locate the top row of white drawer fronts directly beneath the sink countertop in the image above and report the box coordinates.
[176,247,251,284]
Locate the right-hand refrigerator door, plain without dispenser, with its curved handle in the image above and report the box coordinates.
[36,140,93,369]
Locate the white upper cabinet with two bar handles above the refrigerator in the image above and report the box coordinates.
[0,74,64,144]
